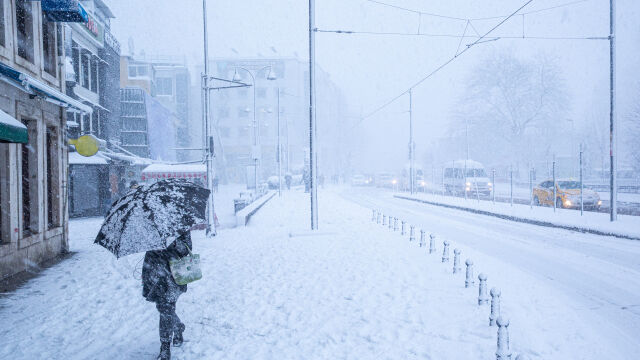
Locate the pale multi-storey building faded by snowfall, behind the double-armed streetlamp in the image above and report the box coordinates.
[211,57,347,184]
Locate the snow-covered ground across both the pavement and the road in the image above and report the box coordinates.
[0,187,640,359]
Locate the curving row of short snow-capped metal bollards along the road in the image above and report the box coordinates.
[371,209,529,360]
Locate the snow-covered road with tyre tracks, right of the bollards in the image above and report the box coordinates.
[342,188,640,354]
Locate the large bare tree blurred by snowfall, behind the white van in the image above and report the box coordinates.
[450,52,567,175]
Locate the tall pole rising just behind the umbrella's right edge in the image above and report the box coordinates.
[202,0,216,236]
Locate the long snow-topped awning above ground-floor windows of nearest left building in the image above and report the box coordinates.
[0,63,93,114]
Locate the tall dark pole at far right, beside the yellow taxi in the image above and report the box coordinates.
[609,0,618,221]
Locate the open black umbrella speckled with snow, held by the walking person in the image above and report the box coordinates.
[95,179,210,257]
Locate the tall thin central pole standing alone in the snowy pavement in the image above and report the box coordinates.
[309,0,318,230]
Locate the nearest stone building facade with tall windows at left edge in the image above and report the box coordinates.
[0,0,92,279]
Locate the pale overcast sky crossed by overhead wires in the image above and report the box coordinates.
[109,0,640,172]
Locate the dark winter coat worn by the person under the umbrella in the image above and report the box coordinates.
[142,232,192,303]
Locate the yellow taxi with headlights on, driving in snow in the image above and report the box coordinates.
[532,179,602,210]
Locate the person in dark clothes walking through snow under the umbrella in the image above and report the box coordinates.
[142,232,192,360]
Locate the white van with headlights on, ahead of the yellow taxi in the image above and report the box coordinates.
[444,160,493,196]
